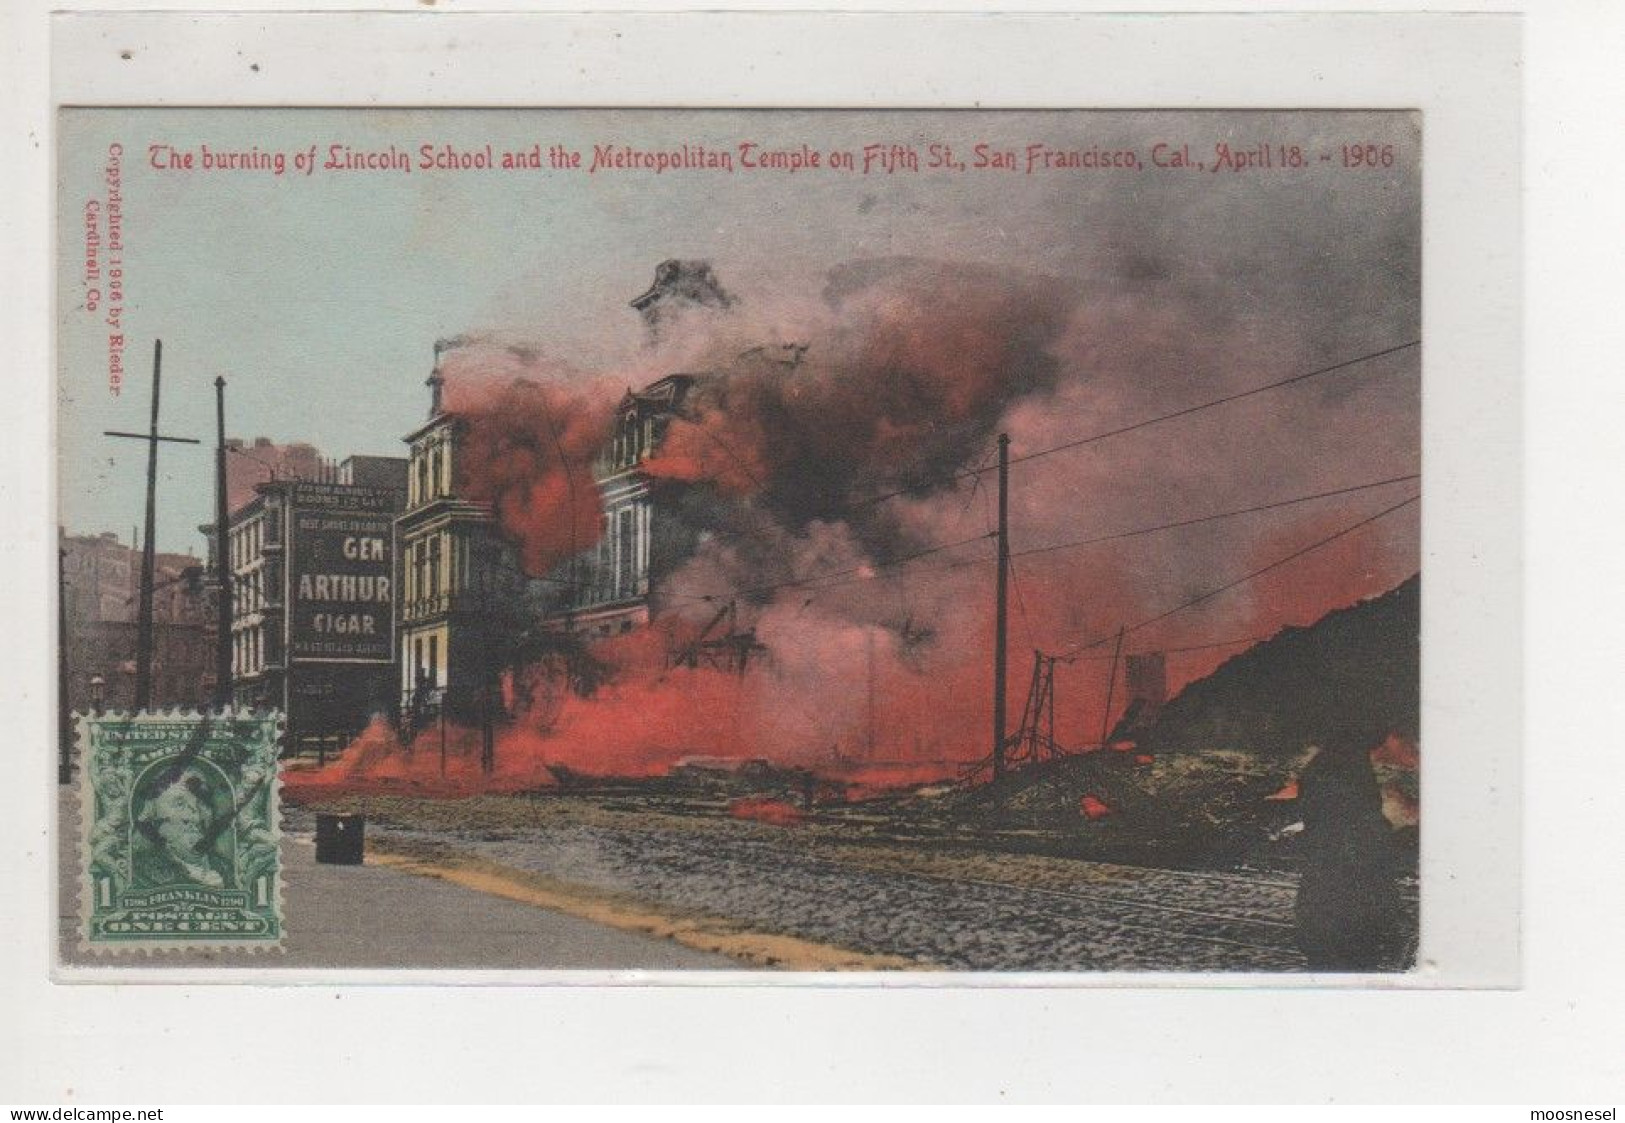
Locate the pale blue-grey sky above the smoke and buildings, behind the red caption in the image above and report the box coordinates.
[59,109,1420,551]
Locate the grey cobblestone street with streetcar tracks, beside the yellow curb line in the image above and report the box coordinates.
[365,827,1302,970]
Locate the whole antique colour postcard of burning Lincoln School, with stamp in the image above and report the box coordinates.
[55,107,1430,977]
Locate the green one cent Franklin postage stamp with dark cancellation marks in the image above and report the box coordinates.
[80,710,283,951]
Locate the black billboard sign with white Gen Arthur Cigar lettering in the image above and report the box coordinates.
[288,484,401,663]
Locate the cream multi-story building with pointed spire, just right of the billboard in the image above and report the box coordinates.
[395,364,530,722]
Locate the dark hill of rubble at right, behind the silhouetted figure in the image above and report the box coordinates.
[954,577,1420,868]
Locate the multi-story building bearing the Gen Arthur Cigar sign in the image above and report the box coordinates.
[205,457,406,752]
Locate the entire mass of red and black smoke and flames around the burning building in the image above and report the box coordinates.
[299,262,1417,791]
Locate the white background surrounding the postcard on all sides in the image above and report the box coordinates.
[0,0,1625,1105]
